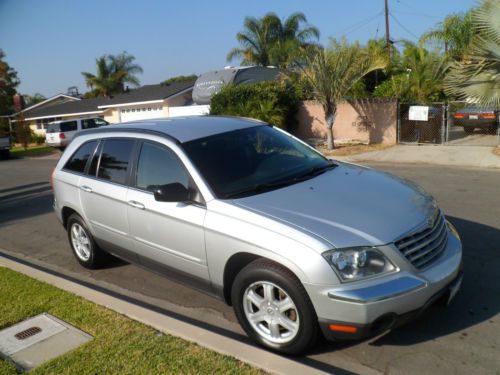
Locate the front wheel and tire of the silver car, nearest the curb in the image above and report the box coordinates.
[231,259,319,355]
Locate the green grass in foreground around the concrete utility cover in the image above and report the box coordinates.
[0,267,262,374]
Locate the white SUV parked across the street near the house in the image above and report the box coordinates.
[45,117,109,149]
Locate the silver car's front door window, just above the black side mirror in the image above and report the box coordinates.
[136,142,189,192]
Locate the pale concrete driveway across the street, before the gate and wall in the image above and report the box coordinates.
[333,145,500,169]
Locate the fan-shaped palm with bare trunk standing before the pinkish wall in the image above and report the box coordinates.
[303,39,387,150]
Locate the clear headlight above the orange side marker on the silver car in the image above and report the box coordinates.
[323,247,396,281]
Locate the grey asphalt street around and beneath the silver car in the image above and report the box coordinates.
[0,153,500,375]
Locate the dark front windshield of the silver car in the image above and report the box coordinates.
[183,125,335,199]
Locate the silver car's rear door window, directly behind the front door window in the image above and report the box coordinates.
[97,139,134,185]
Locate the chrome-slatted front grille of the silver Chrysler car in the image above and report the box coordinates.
[394,211,448,269]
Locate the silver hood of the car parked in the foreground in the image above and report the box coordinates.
[233,163,437,248]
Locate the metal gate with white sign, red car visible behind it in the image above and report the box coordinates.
[398,102,500,147]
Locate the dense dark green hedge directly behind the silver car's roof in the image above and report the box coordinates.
[210,81,299,131]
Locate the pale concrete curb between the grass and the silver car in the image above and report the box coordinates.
[0,255,380,374]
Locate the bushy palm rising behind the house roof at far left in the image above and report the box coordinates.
[82,52,142,97]
